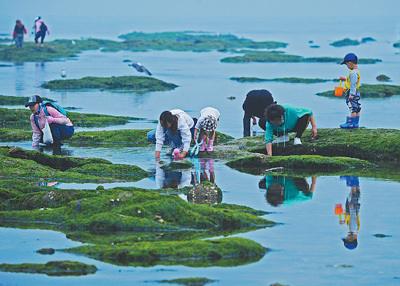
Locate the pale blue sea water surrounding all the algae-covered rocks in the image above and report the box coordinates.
[0,0,400,286]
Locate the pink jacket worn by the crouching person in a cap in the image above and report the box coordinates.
[30,106,72,146]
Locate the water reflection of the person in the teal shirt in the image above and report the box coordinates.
[258,175,317,207]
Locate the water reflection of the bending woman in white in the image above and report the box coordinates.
[154,162,191,189]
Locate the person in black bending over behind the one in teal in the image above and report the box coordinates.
[243,89,276,137]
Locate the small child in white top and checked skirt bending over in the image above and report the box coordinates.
[193,107,220,153]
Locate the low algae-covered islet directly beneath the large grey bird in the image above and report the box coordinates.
[42,76,177,92]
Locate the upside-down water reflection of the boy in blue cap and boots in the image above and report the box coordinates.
[340,176,360,249]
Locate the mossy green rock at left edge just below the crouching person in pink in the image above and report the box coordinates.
[0,146,151,182]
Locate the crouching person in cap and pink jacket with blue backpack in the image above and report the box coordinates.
[25,95,74,147]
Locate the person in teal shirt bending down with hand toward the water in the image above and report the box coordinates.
[265,104,317,156]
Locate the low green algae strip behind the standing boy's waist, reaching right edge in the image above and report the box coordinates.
[317,84,400,98]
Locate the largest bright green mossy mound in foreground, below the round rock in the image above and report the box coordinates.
[0,184,272,231]
